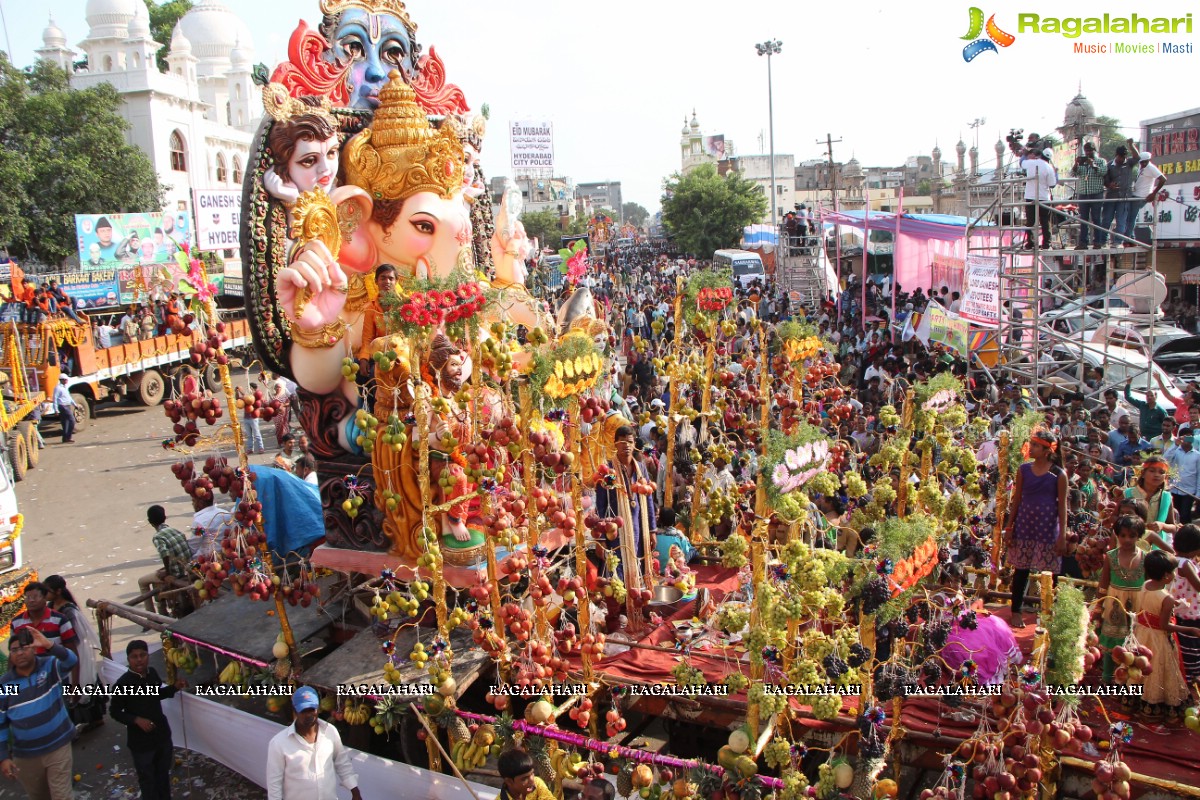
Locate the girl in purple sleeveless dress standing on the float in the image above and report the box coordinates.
[1004,431,1067,627]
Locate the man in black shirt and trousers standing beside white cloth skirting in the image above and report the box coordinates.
[108,639,187,800]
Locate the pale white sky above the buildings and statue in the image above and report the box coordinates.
[0,0,1200,211]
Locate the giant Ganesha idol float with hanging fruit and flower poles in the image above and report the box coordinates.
[88,0,1195,800]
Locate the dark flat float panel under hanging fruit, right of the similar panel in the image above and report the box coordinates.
[298,626,491,694]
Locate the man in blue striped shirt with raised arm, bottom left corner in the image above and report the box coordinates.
[0,626,79,800]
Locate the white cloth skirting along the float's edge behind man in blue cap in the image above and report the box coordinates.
[100,648,499,800]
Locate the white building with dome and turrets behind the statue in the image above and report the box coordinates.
[37,0,263,248]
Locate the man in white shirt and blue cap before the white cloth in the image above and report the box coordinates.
[266,686,362,800]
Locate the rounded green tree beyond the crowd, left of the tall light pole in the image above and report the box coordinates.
[662,164,768,258]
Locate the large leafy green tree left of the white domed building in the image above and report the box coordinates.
[0,55,163,264]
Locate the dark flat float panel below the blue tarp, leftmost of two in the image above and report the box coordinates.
[170,581,343,662]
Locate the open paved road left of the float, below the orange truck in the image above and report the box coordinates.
[15,395,274,800]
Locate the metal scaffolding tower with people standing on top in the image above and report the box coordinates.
[966,157,1160,407]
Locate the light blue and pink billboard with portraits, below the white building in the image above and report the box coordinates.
[76,211,192,272]
